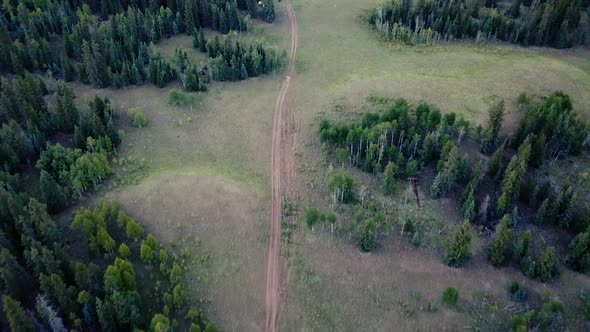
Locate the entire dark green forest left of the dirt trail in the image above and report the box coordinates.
[0,0,286,332]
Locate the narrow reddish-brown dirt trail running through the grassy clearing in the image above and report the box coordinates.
[266,0,297,332]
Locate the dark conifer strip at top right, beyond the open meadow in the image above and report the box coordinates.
[368,0,588,48]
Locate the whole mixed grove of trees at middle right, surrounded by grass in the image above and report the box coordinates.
[319,92,590,282]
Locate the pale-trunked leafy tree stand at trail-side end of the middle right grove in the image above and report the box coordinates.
[320,99,469,184]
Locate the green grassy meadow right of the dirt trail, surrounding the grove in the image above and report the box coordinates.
[282,0,590,330]
